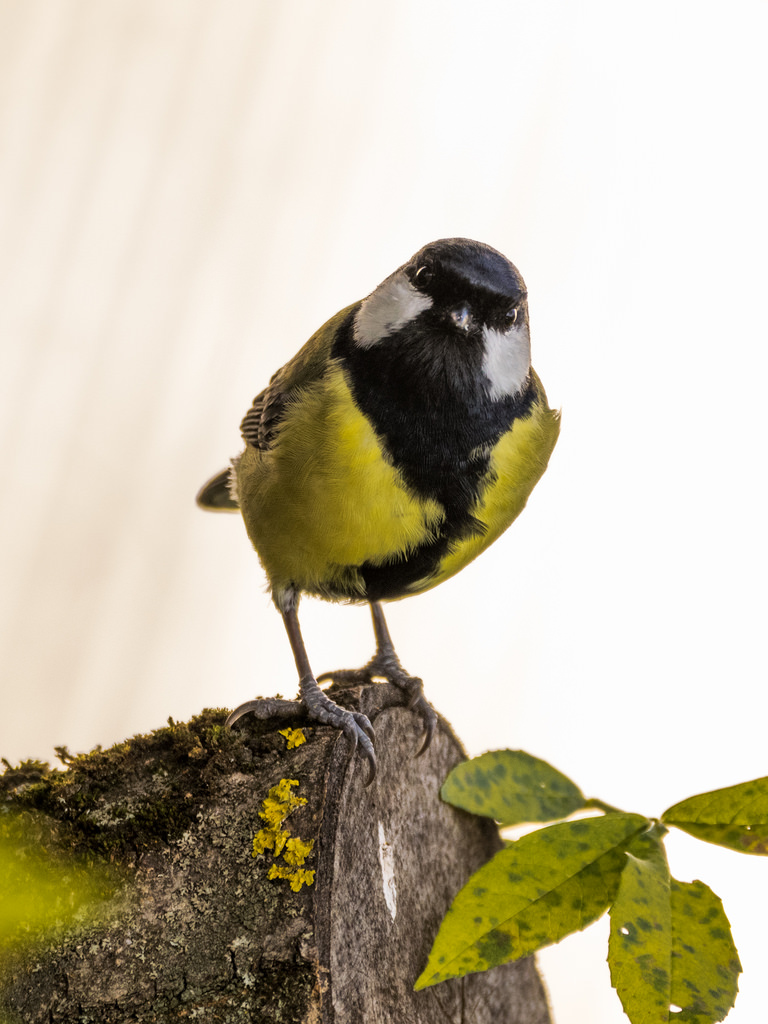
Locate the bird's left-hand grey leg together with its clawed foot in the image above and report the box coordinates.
[226,603,376,785]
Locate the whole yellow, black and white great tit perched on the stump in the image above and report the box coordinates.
[197,238,560,784]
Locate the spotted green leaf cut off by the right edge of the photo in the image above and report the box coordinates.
[662,776,768,856]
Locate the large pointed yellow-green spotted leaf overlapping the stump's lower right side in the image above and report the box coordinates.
[416,814,648,990]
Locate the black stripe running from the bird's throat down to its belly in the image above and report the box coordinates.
[333,309,537,600]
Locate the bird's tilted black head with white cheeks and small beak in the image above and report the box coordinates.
[353,239,530,400]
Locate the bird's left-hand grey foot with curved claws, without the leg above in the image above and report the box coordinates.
[225,677,376,785]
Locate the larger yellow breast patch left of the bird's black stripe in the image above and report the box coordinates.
[237,362,443,597]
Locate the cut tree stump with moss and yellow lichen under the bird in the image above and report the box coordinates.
[0,684,550,1024]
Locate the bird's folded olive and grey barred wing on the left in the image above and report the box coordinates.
[240,302,359,452]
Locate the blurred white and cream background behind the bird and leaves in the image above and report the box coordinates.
[0,0,768,1024]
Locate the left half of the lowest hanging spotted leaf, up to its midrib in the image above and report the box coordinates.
[608,829,672,1024]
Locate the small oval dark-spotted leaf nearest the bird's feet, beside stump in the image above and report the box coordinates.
[440,751,584,825]
